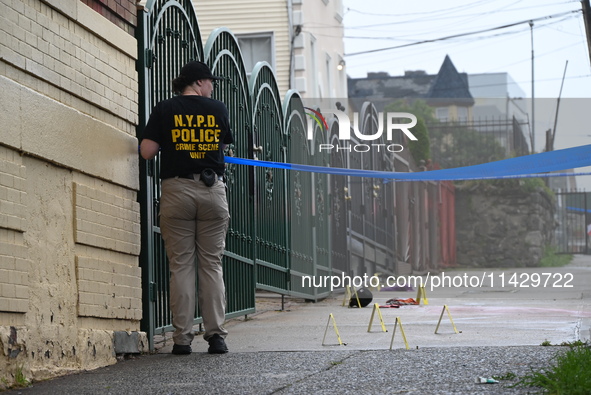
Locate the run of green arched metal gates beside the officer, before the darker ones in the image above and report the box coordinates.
[138,0,331,349]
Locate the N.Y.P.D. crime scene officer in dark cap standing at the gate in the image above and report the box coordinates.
[140,61,234,354]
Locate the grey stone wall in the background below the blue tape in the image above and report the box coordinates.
[456,180,555,267]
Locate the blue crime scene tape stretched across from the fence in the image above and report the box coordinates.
[225,145,591,182]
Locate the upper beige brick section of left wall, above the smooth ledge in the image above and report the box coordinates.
[0,0,138,128]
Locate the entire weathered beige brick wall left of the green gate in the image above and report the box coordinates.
[0,0,142,389]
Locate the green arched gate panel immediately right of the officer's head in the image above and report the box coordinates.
[205,28,256,317]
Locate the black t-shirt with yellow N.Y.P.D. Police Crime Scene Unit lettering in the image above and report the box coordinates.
[143,95,234,179]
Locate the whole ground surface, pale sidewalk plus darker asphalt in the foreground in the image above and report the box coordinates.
[7,256,591,395]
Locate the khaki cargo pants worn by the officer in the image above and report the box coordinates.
[160,174,230,345]
